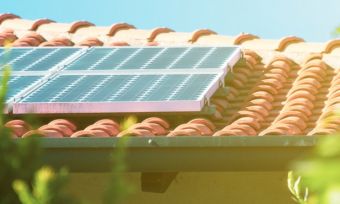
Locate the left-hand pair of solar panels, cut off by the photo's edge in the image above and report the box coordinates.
[0,48,79,102]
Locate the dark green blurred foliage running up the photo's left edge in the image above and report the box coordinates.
[0,63,41,203]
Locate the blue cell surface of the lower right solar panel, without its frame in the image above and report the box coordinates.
[22,74,216,102]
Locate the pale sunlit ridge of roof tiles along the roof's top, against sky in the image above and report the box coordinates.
[0,14,340,54]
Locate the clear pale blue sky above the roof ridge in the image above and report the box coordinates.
[0,0,340,41]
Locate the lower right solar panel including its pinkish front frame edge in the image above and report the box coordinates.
[15,74,218,113]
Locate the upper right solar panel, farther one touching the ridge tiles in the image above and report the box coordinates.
[65,47,236,70]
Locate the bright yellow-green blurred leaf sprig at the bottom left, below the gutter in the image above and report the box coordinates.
[13,167,77,204]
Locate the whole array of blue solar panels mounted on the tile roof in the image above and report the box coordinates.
[0,47,241,114]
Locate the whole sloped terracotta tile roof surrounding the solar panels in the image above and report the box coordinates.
[0,14,340,137]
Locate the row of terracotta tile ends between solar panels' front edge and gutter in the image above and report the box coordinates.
[5,117,215,138]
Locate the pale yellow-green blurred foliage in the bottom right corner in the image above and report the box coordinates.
[294,135,340,204]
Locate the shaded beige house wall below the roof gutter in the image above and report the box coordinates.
[70,172,294,204]
